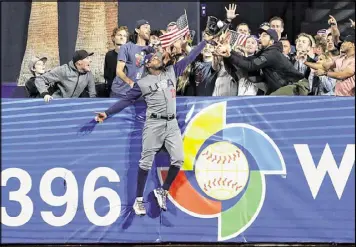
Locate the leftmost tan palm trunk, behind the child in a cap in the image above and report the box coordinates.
[17,1,59,86]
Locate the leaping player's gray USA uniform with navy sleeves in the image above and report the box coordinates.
[105,41,206,170]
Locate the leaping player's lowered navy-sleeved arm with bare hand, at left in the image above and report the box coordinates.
[95,83,142,123]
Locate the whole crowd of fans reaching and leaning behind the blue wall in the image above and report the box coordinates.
[25,4,355,102]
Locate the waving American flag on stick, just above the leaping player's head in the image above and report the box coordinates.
[159,13,189,48]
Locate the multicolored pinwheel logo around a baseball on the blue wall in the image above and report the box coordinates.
[158,102,286,241]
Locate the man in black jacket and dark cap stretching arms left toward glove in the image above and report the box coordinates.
[216,29,308,94]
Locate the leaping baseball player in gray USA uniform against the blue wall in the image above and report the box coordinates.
[95,37,212,215]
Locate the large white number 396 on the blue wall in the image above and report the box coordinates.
[1,167,121,227]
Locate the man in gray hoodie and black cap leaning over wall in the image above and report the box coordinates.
[35,50,96,102]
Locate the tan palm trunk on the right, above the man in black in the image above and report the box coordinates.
[76,0,117,83]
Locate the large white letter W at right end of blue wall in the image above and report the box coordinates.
[294,144,355,200]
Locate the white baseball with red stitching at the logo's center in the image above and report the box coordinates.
[195,141,250,200]
